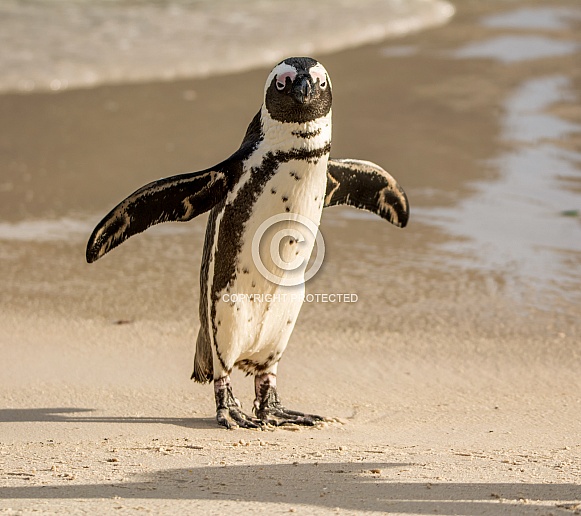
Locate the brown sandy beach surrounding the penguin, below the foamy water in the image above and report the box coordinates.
[0,1,581,514]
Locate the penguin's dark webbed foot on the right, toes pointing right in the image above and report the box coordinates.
[254,373,323,426]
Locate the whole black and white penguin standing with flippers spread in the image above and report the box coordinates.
[86,57,409,428]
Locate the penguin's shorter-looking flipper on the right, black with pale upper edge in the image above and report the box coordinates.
[325,159,409,228]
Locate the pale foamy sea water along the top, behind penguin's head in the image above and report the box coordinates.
[0,0,454,92]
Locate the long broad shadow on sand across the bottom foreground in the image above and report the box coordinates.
[0,463,581,515]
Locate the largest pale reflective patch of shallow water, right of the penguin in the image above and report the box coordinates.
[420,76,581,294]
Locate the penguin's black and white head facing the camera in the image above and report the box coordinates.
[264,57,332,123]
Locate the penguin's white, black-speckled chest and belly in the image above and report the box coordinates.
[209,109,331,361]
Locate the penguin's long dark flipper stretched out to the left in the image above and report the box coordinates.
[86,166,228,263]
